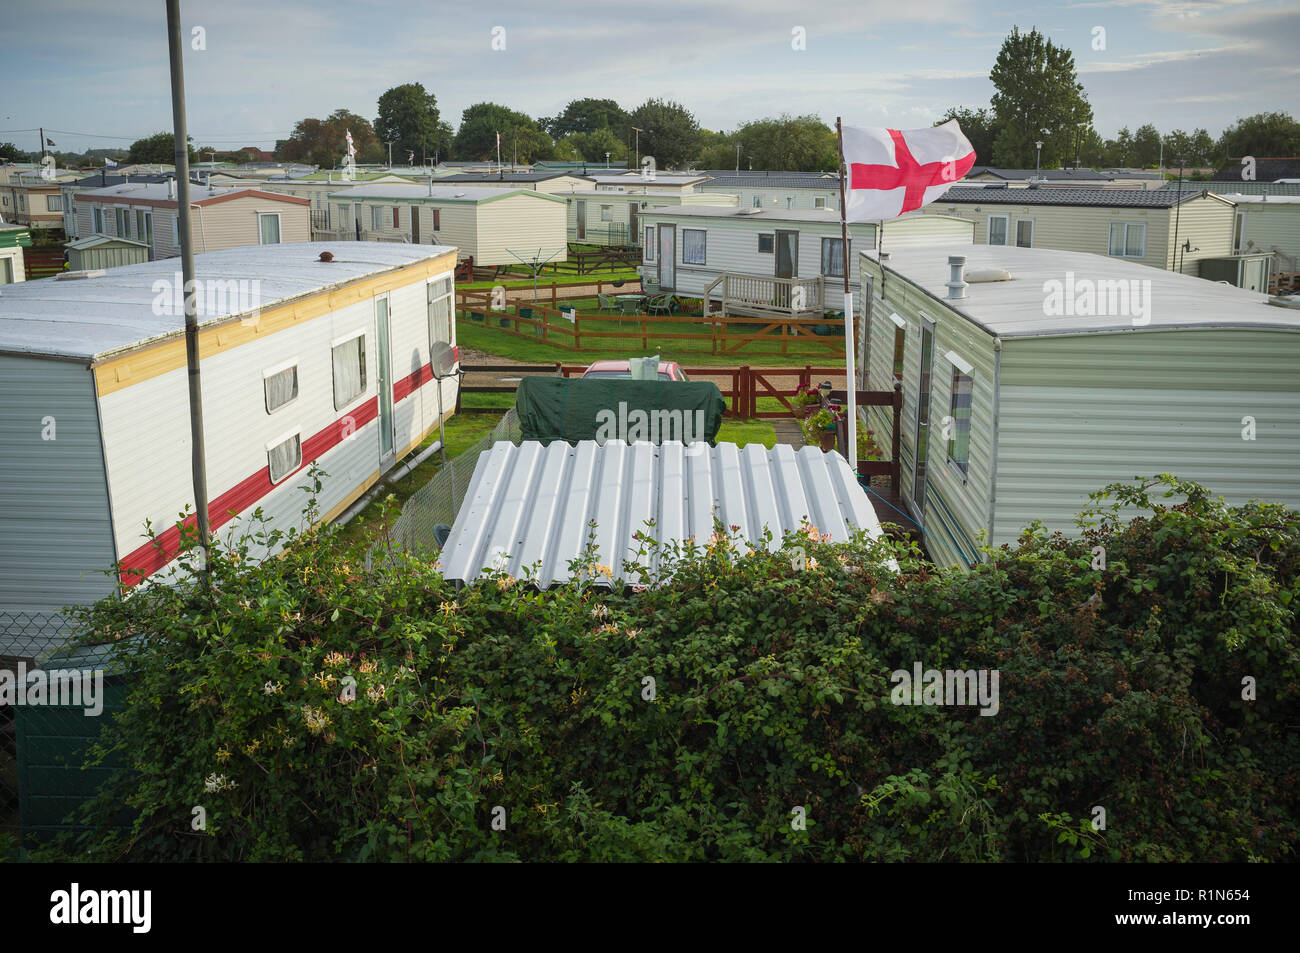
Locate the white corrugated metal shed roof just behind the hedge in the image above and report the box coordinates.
[442,441,881,586]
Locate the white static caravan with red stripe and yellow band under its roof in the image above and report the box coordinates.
[0,242,456,657]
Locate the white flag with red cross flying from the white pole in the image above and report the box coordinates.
[844,120,975,222]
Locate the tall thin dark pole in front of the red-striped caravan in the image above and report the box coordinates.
[166,0,211,572]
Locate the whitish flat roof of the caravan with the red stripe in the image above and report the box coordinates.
[0,242,456,363]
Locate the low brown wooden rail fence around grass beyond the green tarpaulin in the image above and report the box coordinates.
[458,295,844,356]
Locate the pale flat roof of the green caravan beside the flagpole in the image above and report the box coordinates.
[862,245,1300,338]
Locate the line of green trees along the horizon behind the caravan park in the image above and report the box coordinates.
[12,27,1300,172]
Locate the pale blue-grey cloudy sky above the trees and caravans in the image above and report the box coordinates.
[0,0,1300,151]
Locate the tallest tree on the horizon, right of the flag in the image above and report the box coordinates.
[989,27,1092,169]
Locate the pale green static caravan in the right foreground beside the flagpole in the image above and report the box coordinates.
[858,246,1300,566]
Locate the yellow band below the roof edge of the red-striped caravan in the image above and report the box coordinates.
[95,254,456,397]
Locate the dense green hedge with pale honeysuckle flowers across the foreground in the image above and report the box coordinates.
[45,477,1300,861]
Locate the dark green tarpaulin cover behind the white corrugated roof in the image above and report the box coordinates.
[515,377,727,443]
